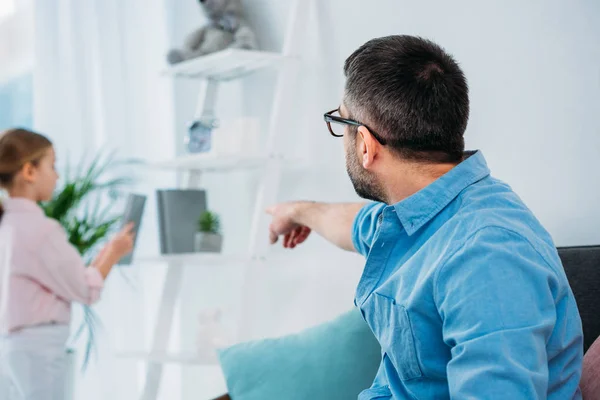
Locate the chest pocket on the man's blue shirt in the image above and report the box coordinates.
[373,293,423,381]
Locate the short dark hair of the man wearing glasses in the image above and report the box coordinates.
[344,35,469,162]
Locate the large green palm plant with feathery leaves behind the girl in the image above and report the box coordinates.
[41,152,133,368]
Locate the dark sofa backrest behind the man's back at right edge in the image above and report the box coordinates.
[558,246,600,351]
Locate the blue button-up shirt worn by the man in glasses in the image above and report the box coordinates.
[353,152,583,400]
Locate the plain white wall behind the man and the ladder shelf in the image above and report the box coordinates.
[165,0,600,396]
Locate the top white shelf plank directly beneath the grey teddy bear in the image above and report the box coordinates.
[163,49,285,81]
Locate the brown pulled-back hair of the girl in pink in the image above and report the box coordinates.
[0,128,52,219]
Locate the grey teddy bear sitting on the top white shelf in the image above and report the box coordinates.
[167,0,258,64]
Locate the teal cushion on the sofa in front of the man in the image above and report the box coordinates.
[219,309,381,400]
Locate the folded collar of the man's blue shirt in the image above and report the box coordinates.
[392,151,490,236]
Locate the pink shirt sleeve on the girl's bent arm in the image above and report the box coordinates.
[32,221,104,304]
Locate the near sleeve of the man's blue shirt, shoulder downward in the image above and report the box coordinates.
[435,228,559,399]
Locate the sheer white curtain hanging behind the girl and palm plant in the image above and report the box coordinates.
[34,0,175,400]
